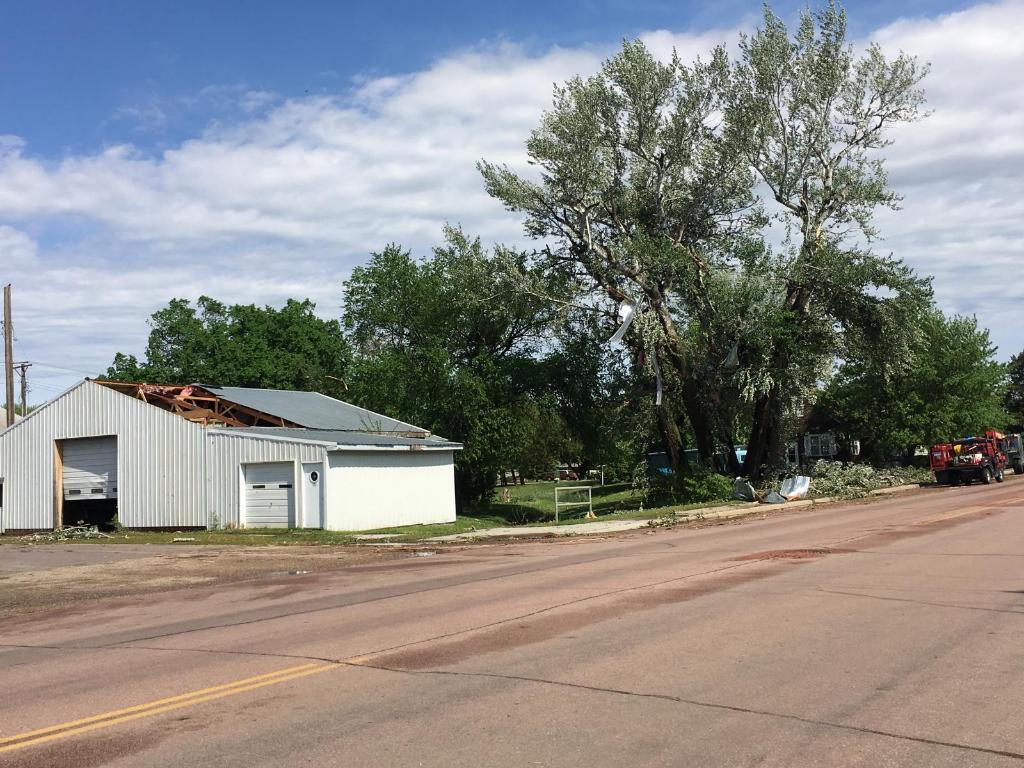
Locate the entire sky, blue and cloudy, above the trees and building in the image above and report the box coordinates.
[0,0,1024,402]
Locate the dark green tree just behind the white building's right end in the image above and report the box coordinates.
[344,228,560,502]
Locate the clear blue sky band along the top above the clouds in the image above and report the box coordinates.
[0,0,964,155]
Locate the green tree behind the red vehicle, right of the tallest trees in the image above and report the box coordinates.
[822,310,1007,462]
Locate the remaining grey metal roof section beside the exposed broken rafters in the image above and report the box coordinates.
[194,384,430,437]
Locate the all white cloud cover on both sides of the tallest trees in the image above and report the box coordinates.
[0,1,1024,403]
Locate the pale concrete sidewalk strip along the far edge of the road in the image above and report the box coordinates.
[423,484,922,542]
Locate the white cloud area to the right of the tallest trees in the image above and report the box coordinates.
[872,0,1024,357]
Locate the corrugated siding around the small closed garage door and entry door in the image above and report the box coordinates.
[206,431,327,527]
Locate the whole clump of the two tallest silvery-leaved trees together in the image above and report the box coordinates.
[480,5,930,475]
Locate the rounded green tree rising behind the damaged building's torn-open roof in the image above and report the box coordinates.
[106,296,351,393]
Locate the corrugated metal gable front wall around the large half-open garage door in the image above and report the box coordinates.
[0,381,207,531]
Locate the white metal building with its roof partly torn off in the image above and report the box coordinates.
[0,380,462,532]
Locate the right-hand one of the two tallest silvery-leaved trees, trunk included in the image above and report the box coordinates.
[725,3,928,474]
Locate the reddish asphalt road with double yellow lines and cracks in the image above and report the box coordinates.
[0,477,1024,768]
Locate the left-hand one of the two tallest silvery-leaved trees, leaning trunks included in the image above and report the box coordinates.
[479,41,752,475]
